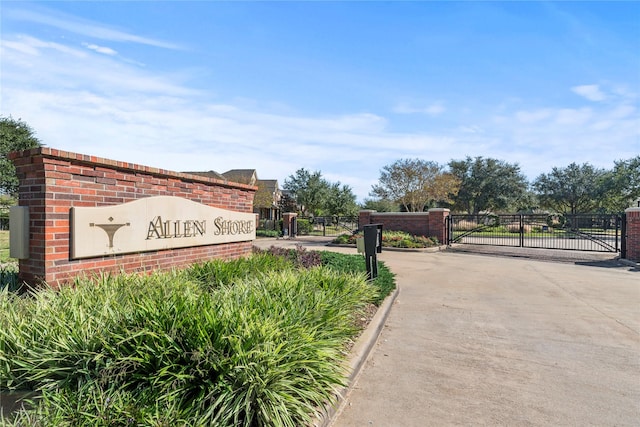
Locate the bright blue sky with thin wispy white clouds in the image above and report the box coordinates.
[0,0,640,201]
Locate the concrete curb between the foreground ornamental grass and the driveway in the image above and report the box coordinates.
[313,284,400,427]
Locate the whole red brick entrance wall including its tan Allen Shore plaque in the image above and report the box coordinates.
[9,147,256,287]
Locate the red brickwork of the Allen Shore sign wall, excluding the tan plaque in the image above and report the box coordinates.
[9,147,256,287]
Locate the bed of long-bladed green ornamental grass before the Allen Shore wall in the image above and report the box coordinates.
[0,259,376,426]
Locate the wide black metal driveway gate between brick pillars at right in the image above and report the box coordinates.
[447,214,624,255]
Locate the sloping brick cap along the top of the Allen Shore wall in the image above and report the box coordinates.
[7,147,258,191]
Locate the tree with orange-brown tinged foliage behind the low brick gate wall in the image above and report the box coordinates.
[370,159,459,212]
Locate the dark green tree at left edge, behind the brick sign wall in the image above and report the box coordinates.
[0,116,42,197]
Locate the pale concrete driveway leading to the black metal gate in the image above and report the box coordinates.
[255,240,640,427]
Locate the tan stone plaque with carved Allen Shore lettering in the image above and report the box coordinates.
[70,196,256,259]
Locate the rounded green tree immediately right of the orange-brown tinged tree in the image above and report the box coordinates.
[449,157,529,214]
